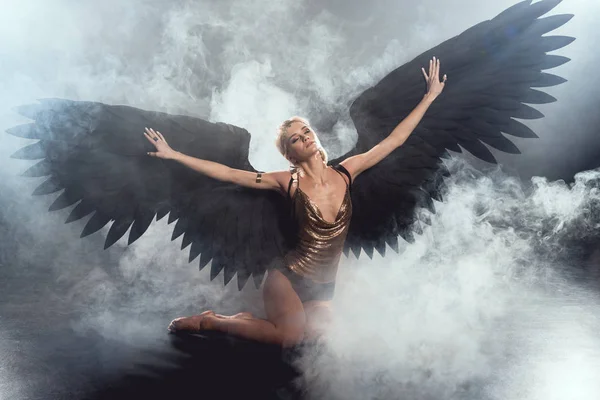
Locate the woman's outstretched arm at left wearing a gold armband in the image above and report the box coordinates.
[144,128,289,192]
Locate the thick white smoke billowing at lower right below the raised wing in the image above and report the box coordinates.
[300,161,600,399]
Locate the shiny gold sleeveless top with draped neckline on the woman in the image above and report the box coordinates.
[285,170,352,283]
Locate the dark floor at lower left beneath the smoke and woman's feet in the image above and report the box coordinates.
[0,292,299,399]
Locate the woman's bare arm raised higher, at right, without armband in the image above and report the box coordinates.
[341,57,446,179]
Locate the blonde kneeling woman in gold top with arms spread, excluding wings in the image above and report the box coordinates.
[144,57,446,347]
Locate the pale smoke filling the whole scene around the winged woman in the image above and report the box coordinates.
[0,0,599,399]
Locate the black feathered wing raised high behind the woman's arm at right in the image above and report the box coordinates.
[331,0,574,257]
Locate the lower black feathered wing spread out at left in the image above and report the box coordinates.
[8,99,287,289]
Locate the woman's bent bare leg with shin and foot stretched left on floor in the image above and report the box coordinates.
[169,270,306,347]
